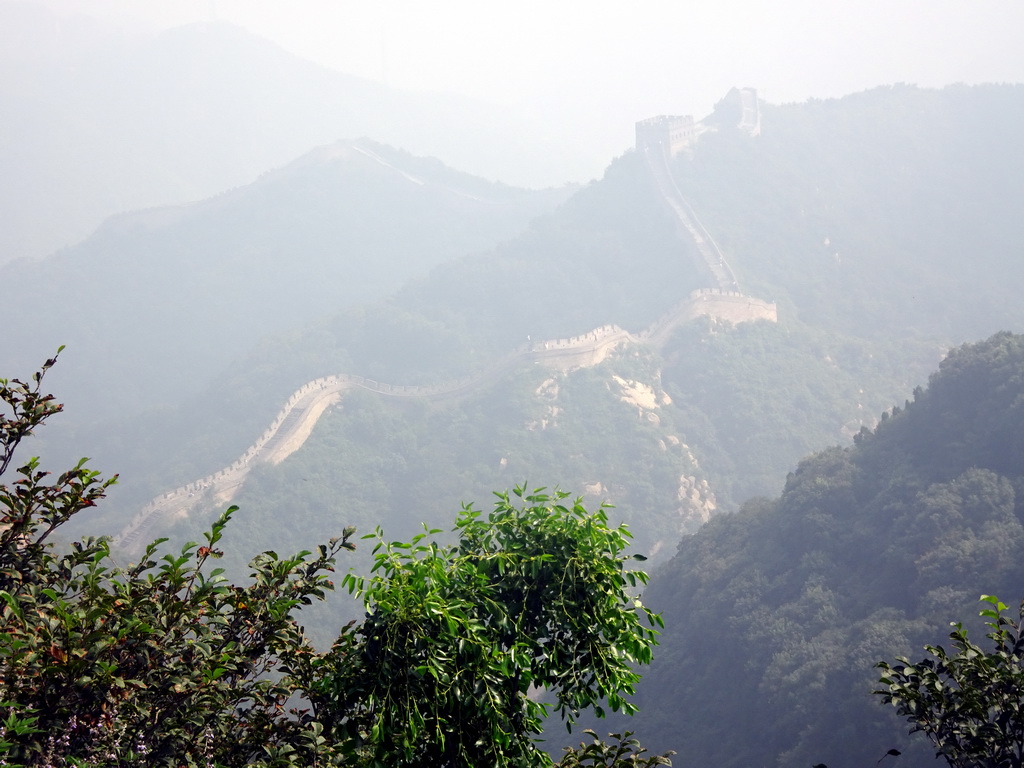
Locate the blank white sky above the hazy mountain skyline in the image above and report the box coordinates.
[24,0,1024,165]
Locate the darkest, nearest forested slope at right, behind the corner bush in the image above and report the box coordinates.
[606,333,1024,768]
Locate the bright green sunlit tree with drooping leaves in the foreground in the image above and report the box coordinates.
[313,488,660,766]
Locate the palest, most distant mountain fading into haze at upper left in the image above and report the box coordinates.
[0,2,583,263]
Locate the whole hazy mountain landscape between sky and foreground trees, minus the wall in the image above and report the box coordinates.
[0,4,1024,768]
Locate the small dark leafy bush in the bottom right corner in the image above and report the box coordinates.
[874,595,1024,768]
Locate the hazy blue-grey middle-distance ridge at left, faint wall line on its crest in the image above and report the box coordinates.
[0,139,570,466]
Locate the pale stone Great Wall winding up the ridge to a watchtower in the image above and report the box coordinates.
[112,99,778,553]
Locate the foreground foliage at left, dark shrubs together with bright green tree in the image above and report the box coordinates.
[0,357,668,767]
